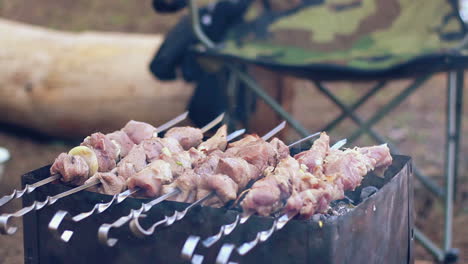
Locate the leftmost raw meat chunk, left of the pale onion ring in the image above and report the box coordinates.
[50,153,89,185]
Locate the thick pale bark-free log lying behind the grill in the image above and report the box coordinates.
[0,19,193,137]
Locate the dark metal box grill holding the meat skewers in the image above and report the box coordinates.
[22,155,413,263]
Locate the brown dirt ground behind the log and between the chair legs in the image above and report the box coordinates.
[0,0,468,264]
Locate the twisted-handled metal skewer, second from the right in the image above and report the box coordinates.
[181,132,328,259]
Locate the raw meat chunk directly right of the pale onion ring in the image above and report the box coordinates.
[81,133,118,172]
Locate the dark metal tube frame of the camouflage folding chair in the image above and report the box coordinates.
[189,0,465,263]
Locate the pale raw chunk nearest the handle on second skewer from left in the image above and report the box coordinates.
[86,171,127,195]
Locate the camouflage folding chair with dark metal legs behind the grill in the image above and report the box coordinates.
[155,0,468,263]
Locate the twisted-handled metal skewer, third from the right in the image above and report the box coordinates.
[130,121,286,237]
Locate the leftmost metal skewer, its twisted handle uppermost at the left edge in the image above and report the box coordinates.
[0,112,188,207]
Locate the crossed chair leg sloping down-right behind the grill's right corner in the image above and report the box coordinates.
[315,82,444,198]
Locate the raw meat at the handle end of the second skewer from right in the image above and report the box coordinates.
[241,157,305,216]
